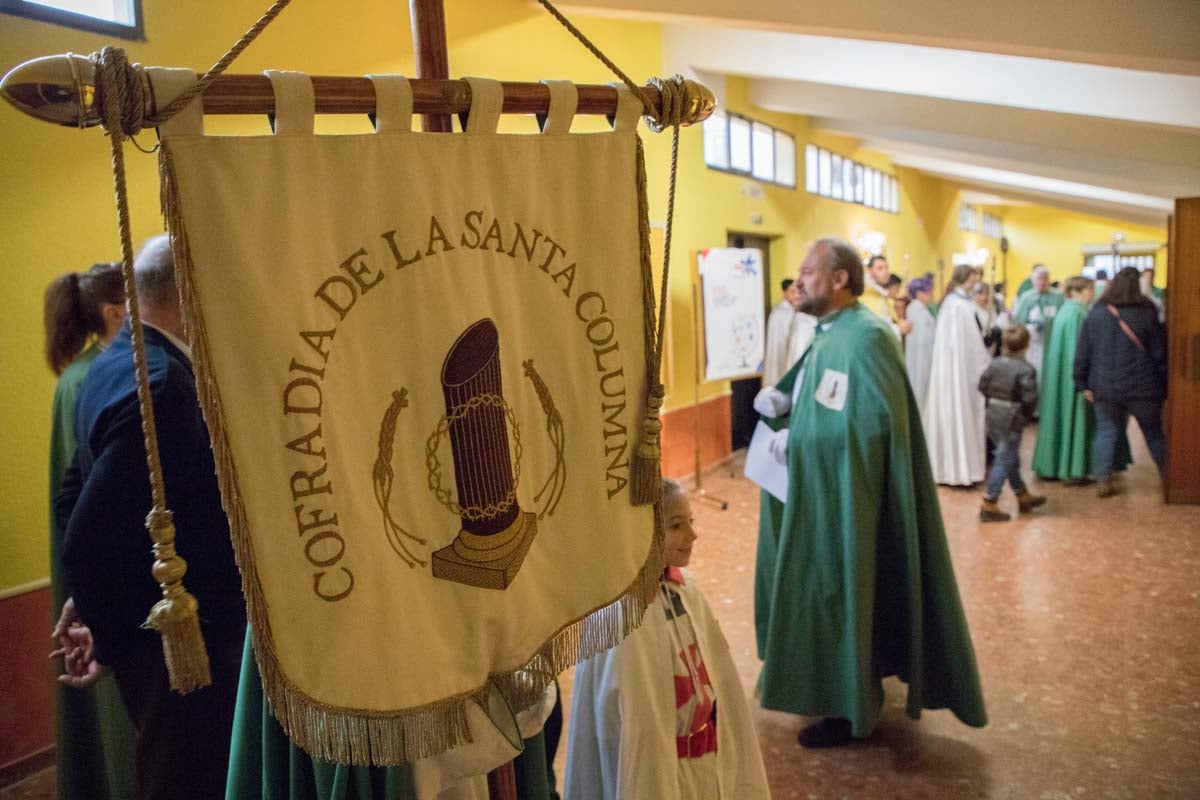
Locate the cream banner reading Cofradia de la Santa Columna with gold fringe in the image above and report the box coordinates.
[152,71,661,764]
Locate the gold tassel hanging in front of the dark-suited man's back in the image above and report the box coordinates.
[143,509,212,694]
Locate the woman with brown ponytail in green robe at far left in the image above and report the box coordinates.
[44,264,138,800]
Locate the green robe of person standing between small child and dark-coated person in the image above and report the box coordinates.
[1033,300,1096,480]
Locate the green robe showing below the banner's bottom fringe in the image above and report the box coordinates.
[226,631,550,800]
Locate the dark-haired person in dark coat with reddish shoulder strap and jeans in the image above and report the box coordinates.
[1074,267,1166,498]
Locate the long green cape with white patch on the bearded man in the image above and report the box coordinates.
[758,303,988,736]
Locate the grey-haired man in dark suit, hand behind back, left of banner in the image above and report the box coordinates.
[55,236,246,799]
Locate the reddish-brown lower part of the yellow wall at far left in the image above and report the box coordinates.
[0,587,54,780]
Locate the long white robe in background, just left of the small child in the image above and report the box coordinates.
[920,290,991,486]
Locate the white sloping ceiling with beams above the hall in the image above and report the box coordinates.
[569,0,1200,225]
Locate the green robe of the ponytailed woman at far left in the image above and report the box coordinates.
[50,343,138,800]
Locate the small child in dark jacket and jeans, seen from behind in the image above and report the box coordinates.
[979,325,1046,522]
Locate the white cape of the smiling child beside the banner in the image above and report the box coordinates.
[563,572,770,800]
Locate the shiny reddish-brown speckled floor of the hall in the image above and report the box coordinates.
[11,424,1200,800]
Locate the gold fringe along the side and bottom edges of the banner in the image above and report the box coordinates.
[158,142,665,766]
